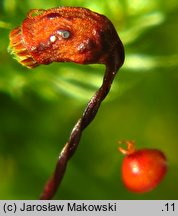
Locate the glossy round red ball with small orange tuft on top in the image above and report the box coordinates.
[119,141,167,193]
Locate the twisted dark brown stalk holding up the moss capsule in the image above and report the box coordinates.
[40,42,124,199]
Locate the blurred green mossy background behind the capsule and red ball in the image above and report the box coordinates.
[0,0,178,199]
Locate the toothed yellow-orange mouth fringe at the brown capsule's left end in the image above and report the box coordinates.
[8,26,39,68]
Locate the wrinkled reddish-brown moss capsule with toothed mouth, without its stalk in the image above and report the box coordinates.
[9,7,124,68]
